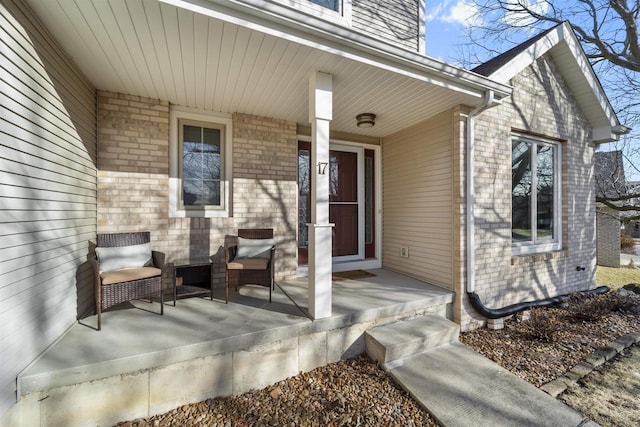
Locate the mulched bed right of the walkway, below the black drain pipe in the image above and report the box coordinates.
[460,291,640,387]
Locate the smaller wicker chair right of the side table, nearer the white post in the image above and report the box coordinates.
[225,228,275,303]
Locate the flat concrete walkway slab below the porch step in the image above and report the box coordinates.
[388,342,597,427]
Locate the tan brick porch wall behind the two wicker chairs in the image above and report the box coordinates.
[98,92,297,287]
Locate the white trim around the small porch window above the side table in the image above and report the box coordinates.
[169,105,233,218]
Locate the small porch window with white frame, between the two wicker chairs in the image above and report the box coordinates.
[169,107,231,217]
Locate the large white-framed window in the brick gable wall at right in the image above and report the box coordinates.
[511,134,562,255]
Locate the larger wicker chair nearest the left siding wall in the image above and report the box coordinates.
[91,231,165,330]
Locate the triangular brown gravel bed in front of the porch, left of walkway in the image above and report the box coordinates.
[118,356,438,427]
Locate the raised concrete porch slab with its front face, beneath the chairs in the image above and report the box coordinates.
[18,269,453,426]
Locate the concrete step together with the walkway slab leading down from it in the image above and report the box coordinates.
[367,317,598,427]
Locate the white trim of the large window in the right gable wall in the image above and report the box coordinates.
[511,132,562,255]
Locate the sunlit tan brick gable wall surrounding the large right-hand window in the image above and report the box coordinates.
[456,57,596,329]
